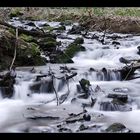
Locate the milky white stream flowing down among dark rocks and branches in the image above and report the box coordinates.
[0,20,140,133]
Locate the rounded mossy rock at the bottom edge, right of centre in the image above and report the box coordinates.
[105,123,131,133]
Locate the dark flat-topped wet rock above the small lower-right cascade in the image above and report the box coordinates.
[107,94,128,103]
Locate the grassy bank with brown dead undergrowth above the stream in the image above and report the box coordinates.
[8,7,140,33]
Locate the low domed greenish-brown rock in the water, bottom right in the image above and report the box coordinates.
[106,123,126,132]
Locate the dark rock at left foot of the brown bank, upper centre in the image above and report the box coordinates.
[68,25,84,34]
